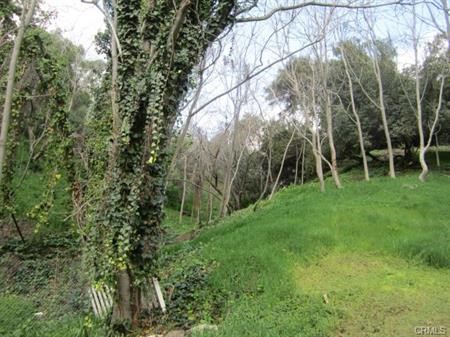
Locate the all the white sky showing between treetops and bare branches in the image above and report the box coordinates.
[43,0,446,131]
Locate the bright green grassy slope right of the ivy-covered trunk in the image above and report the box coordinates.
[171,174,450,337]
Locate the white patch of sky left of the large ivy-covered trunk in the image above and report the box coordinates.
[43,0,104,58]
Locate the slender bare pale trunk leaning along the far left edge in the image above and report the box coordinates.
[0,0,37,183]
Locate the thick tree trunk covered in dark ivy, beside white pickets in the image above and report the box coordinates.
[88,0,235,330]
